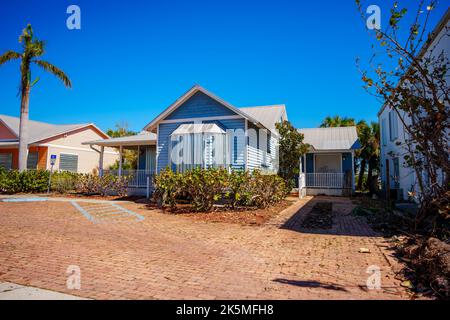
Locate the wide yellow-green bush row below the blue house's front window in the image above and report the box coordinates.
[153,168,287,211]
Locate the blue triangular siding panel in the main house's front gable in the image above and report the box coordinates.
[165,92,236,120]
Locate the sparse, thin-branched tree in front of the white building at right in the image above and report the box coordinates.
[356,0,450,228]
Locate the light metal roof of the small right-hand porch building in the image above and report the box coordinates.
[298,127,360,150]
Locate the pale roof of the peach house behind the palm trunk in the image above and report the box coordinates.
[0,114,108,144]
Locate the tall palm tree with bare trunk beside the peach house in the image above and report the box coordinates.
[0,24,72,171]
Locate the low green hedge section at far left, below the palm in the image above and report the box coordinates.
[0,168,49,193]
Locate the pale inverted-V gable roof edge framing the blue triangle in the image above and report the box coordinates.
[144,84,270,131]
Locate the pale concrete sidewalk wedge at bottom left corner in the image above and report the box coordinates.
[0,282,87,300]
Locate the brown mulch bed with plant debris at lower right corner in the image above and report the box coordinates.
[353,197,450,300]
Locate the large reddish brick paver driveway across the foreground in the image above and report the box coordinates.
[0,198,407,299]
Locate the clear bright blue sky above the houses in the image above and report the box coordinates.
[0,0,446,131]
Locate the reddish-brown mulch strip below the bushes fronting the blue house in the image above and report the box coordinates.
[147,199,295,225]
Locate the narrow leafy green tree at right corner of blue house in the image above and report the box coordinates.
[276,121,309,190]
